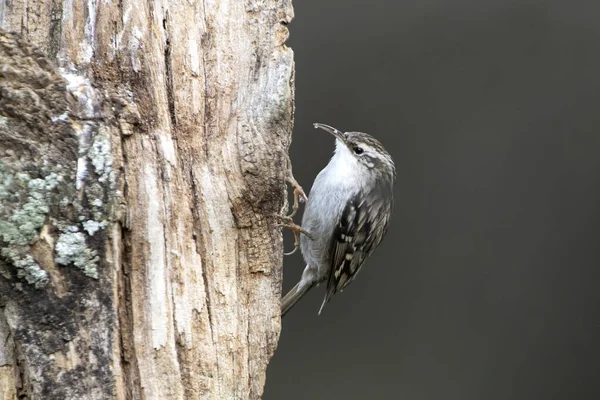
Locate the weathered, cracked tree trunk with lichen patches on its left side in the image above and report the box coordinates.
[0,0,294,400]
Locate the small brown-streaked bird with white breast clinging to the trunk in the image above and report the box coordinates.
[281,123,396,316]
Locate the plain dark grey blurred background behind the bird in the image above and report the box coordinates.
[264,0,600,400]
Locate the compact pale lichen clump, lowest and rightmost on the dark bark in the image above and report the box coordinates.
[54,226,100,279]
